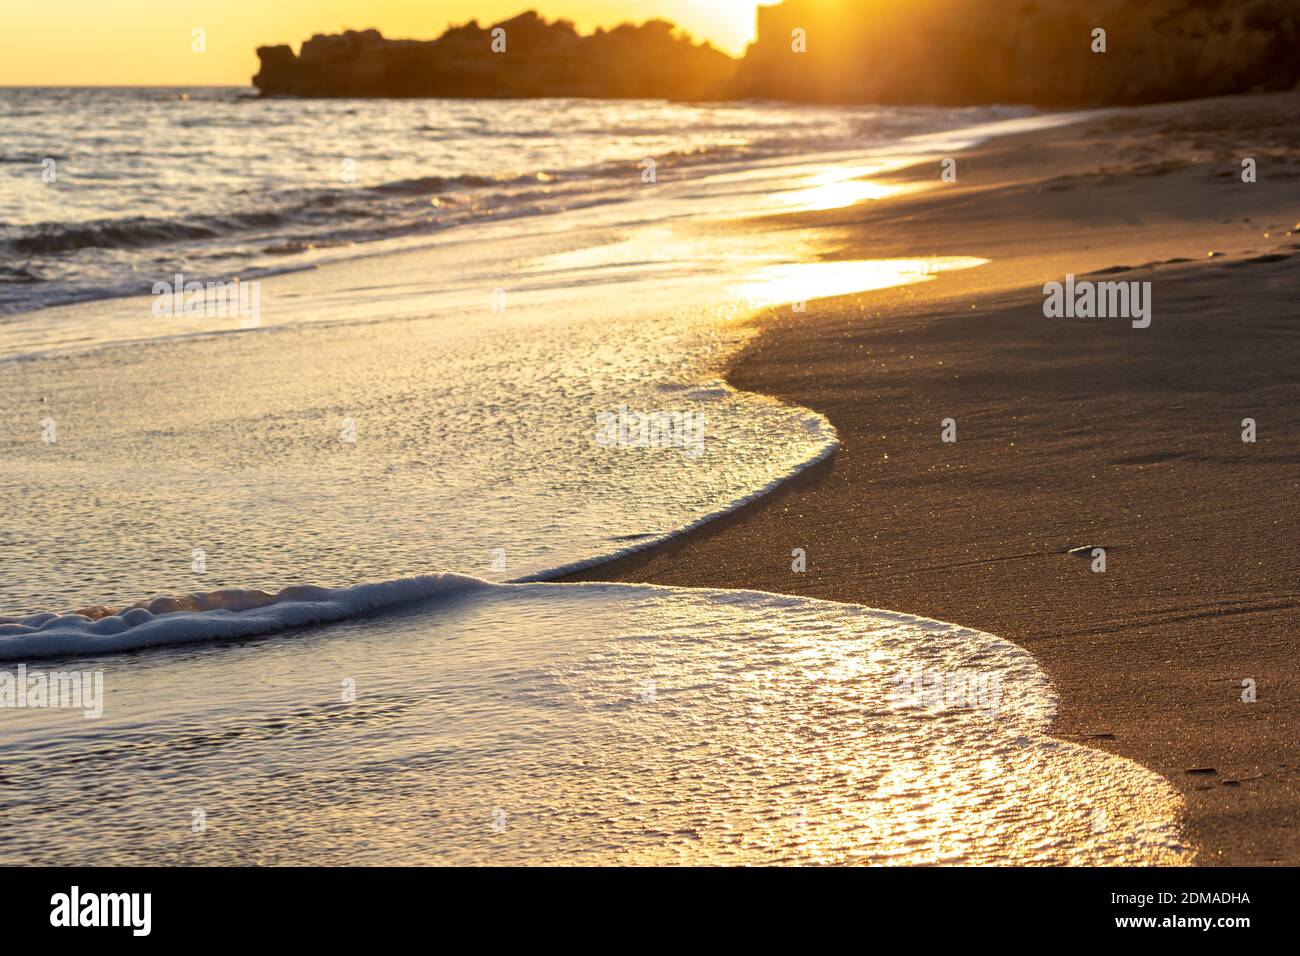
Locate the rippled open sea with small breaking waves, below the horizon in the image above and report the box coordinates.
[0,87,1027,316]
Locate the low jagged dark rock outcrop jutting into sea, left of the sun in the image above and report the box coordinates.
[252,13,736,99]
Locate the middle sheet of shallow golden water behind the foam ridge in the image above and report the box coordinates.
[0,121,1019,617]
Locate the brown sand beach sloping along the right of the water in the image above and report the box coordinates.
[573,94,1300,865]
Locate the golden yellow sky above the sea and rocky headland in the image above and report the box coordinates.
[0,0,771,86]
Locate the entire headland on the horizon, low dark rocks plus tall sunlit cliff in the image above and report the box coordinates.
[254,0,1300,108]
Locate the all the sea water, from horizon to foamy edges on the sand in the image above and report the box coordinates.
[0,91,1190,864]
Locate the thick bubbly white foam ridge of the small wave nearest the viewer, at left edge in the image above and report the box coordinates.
[0,574,490,661]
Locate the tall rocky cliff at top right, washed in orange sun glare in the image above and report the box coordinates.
[731,0,1300,107]
